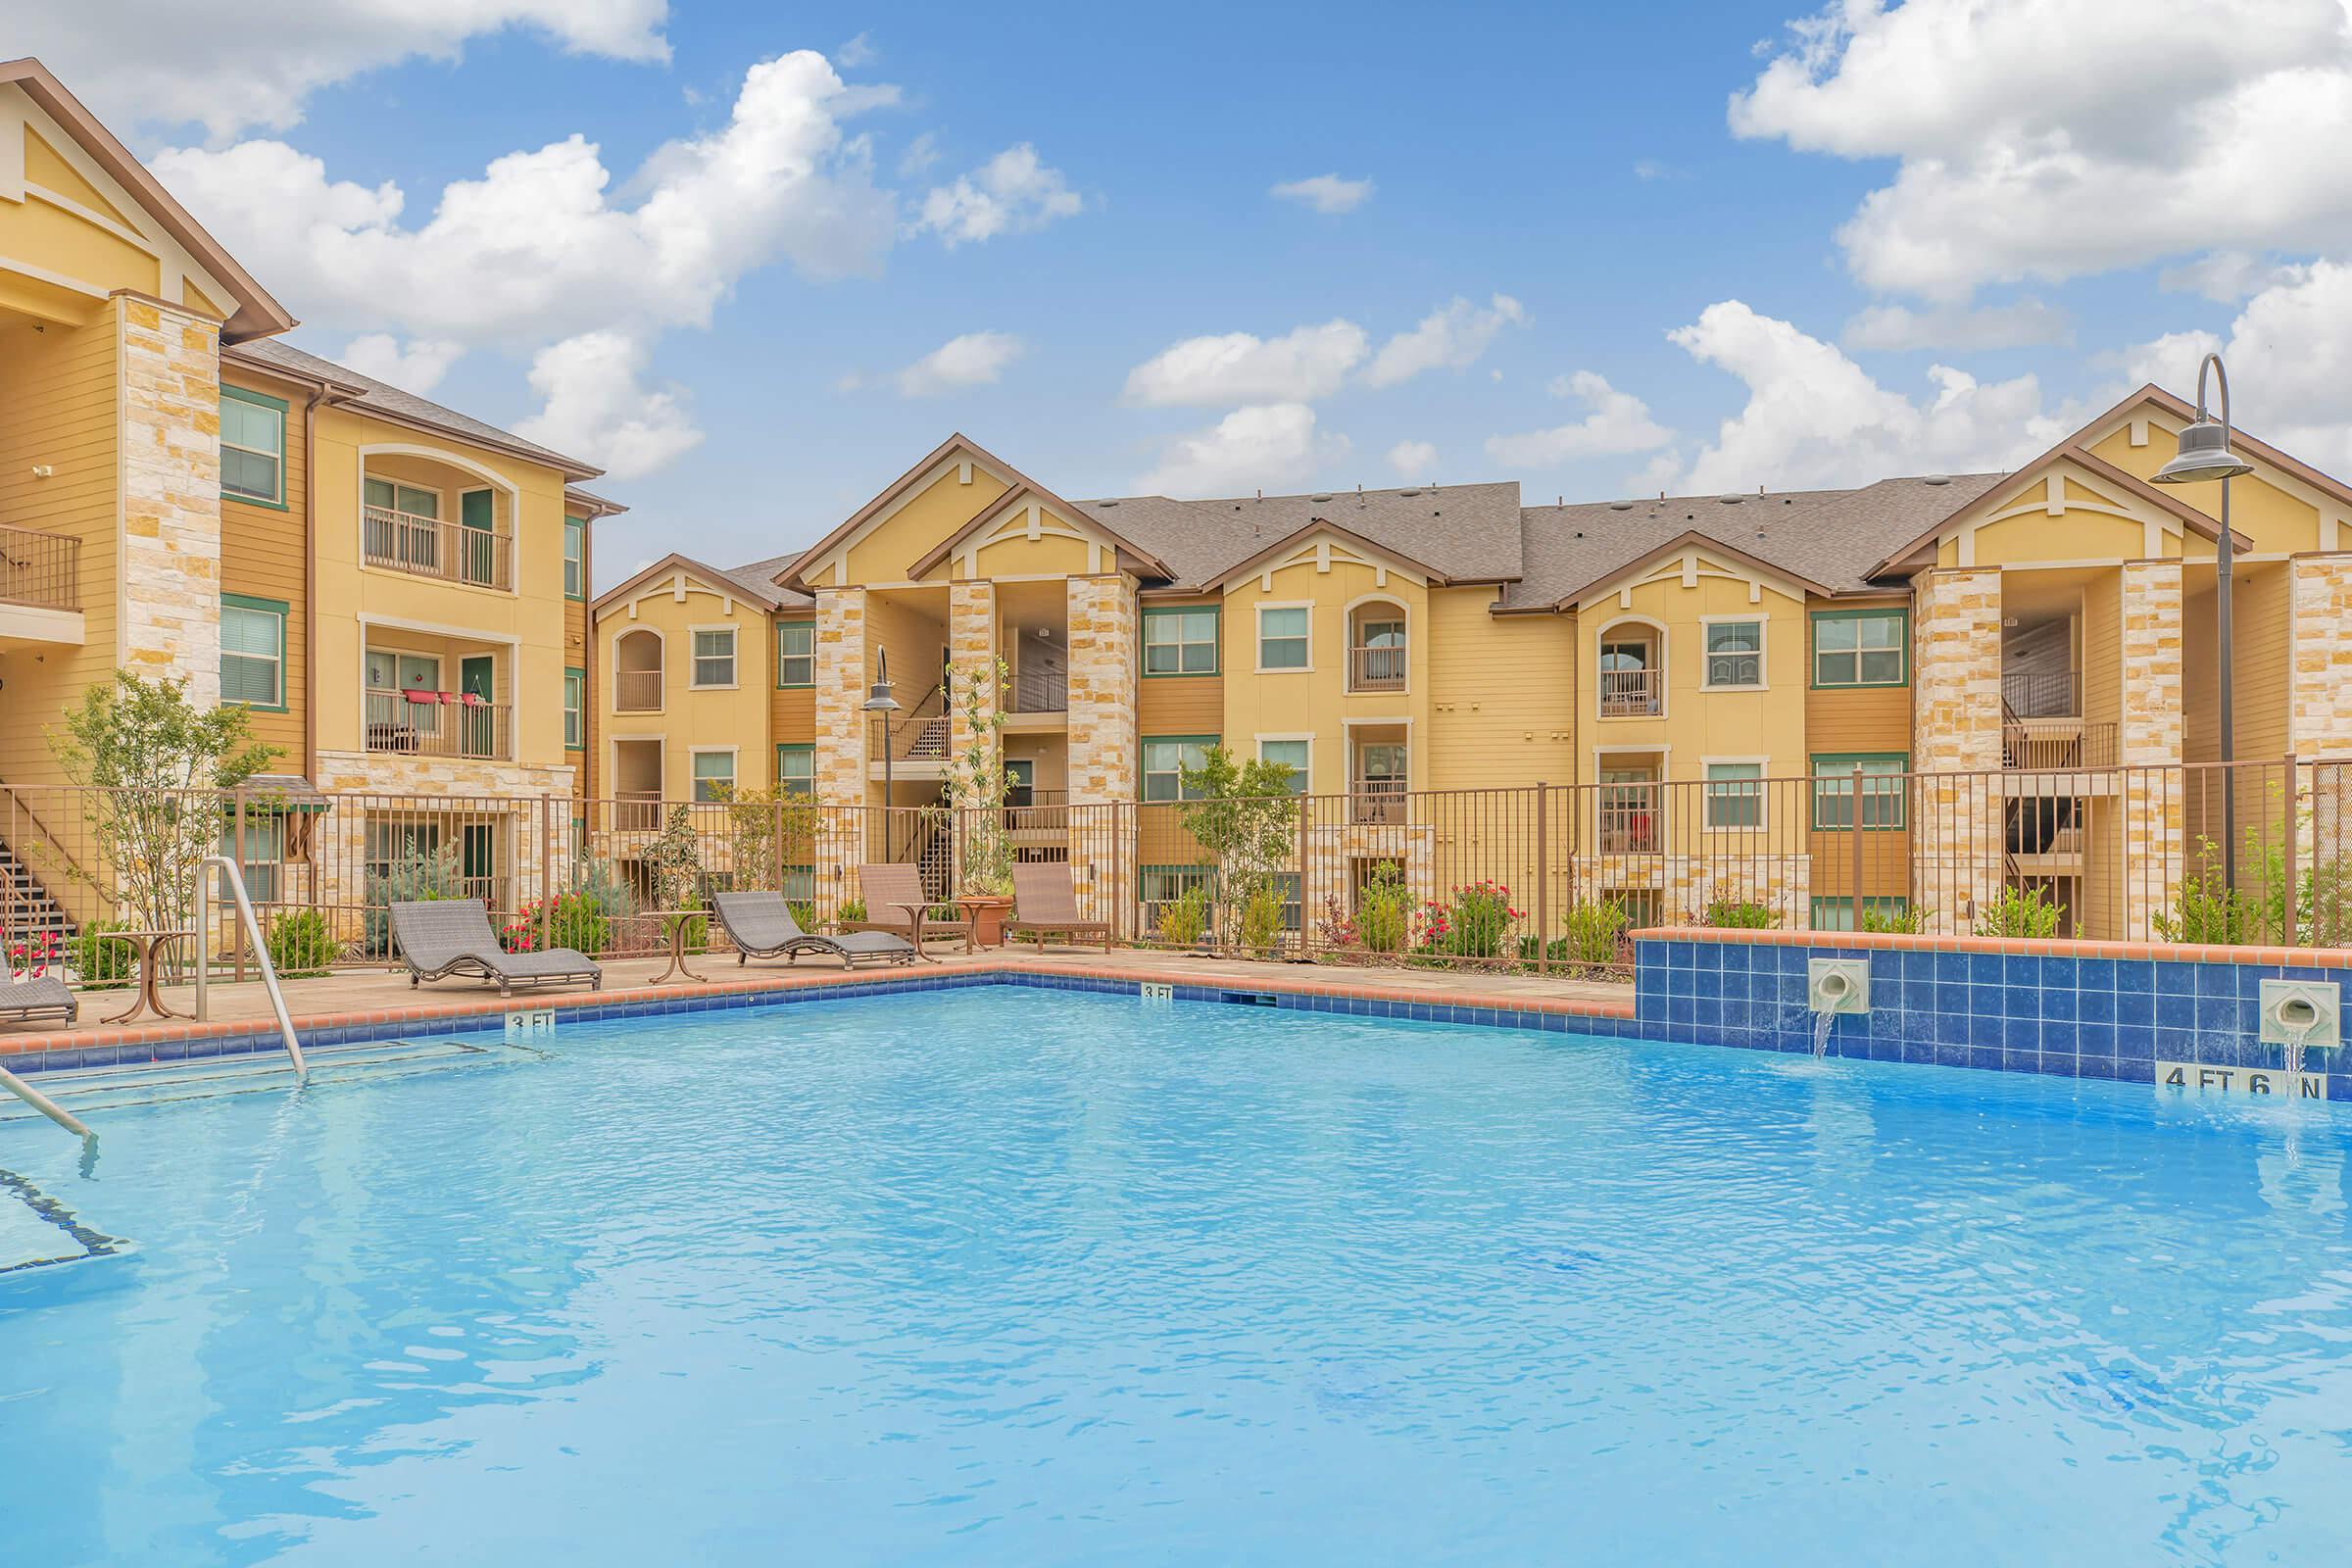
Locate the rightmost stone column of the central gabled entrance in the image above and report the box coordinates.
[1068,576,1139,921]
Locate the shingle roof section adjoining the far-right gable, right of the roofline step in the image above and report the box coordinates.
[1503,472,2001,609]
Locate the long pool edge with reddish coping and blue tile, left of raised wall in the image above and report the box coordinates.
[0,956,1635,1072]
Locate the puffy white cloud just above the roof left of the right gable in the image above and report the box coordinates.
[1651,299,2080,494]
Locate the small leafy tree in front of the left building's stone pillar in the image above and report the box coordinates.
[49,670,277,931]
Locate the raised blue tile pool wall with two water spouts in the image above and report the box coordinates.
[1635,941,2352,1101]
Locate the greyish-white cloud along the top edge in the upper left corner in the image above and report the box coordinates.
[23,0,670,141]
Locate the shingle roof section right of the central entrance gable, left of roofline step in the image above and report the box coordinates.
[1077,484,1519,588]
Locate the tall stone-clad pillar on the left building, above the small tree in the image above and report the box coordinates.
[113,294,221,708]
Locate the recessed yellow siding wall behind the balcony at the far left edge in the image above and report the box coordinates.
[0,313,118,785]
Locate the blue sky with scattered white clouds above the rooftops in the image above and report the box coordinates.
[10,0,2352,588]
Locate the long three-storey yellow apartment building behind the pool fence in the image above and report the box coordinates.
[595,399,2352,933]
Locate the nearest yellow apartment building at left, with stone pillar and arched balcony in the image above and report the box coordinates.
[0,61,618,930]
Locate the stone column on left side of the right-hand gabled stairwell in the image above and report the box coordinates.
[1909,566,2006,931]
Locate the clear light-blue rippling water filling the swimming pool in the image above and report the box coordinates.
[0,987,2352,1563]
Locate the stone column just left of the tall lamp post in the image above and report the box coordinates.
[2126,562,2191,941]
